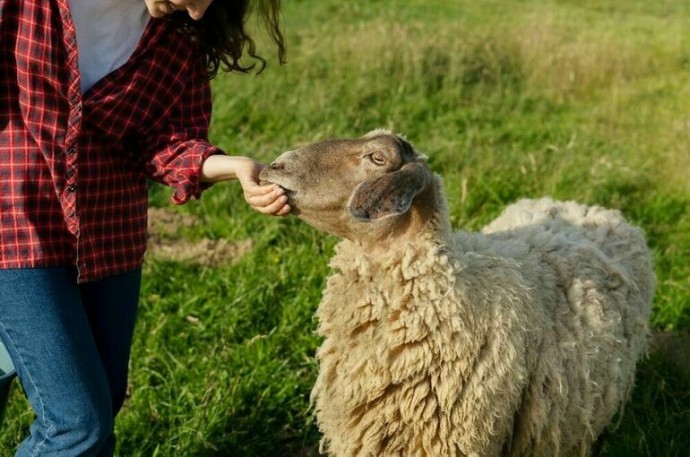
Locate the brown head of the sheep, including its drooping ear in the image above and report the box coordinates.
[261,130,430,239]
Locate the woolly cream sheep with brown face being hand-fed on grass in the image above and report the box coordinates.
[260,130,654,457]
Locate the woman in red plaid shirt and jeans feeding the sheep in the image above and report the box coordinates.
[0,0,290,457]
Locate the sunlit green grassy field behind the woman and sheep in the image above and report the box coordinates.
[0,0,690,457]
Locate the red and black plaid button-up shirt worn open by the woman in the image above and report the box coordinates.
[0,0,221,282]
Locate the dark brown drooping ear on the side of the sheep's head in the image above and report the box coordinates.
[348,163,428,222]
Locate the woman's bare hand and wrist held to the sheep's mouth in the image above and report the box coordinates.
[201,155,290,216]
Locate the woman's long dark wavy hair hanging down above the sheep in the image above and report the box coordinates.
[172,0,285,78]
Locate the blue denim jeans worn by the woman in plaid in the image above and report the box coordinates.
[0,267,141,457]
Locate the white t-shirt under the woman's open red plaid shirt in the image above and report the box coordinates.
[69,0,150,93]
